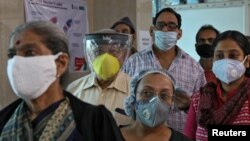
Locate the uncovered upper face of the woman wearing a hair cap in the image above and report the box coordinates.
[136,73,174,105]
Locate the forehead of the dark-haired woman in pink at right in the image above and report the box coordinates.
[214,38,243,54]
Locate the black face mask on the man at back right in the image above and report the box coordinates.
[196,44,213,58]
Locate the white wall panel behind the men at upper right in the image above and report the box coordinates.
[167,0,250,60]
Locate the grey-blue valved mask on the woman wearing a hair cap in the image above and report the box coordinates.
[135,97,171,127]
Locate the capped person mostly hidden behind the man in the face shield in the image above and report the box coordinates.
[111,17,137,56]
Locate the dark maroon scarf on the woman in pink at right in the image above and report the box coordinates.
[197,78,250,128]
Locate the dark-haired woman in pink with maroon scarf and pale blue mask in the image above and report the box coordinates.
[184,30,250,141]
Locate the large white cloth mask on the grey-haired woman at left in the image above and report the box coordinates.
[7,53,61,100]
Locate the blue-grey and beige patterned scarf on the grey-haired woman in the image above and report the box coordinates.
[0,98,75,141]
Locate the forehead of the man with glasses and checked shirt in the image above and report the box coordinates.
[156,12,178,24]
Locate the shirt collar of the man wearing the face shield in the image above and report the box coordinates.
[82,72,129,94]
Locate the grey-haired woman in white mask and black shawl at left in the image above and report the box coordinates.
[0,21,124,141]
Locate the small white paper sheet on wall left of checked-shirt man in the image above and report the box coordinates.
[137,30,152,51]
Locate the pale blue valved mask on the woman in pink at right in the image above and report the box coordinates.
[212,58,246,84]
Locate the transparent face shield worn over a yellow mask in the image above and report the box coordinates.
[84,33,132,71]
